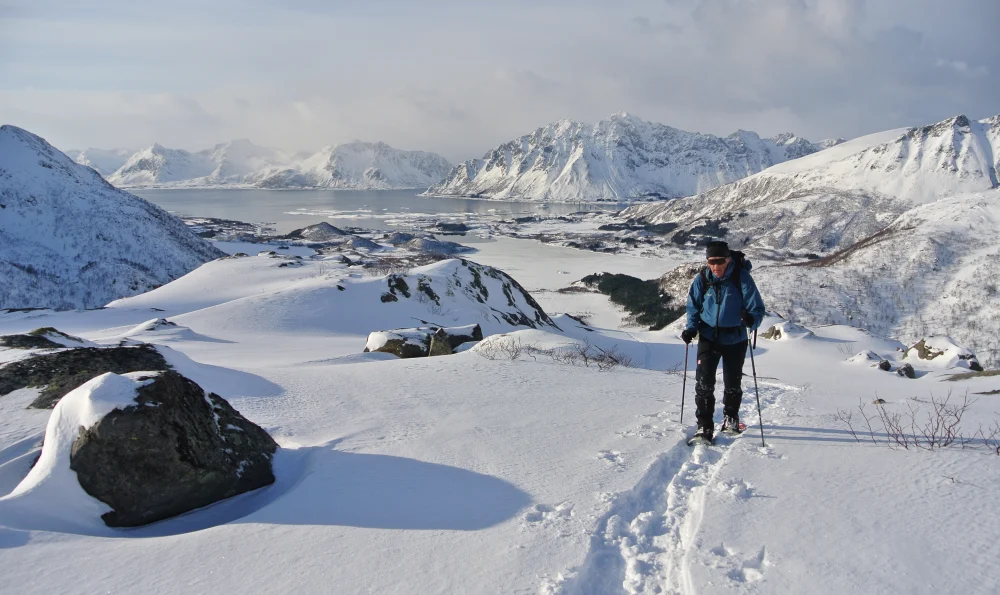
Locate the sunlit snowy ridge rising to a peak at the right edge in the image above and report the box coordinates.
[619,116,1000,253]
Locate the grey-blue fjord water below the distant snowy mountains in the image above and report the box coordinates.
[129,188,604,233]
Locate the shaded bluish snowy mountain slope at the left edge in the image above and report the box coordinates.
[0,125,222,309]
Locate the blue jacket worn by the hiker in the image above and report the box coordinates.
[687,260,764,345]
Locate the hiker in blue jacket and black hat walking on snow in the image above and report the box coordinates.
[681,241,764,441]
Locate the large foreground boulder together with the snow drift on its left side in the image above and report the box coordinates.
[0,371,277,527]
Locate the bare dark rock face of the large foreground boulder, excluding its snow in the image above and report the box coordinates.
[70,371,278,527]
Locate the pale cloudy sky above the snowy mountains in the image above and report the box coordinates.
[0,0,1000,162]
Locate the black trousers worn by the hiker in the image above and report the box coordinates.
[694,339,747,426]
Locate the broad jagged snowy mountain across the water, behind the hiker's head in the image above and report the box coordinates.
[427,113,838,201]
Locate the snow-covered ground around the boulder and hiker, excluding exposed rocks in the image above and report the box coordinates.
[0,238,1000,594]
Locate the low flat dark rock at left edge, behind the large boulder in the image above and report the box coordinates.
[0,345,170,409]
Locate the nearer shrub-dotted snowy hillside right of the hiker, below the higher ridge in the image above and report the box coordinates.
[755,190,1000,366]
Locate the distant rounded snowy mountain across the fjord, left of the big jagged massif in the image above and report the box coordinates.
[247,141,451,190]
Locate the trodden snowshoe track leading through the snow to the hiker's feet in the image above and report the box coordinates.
[542,383,796,595]
